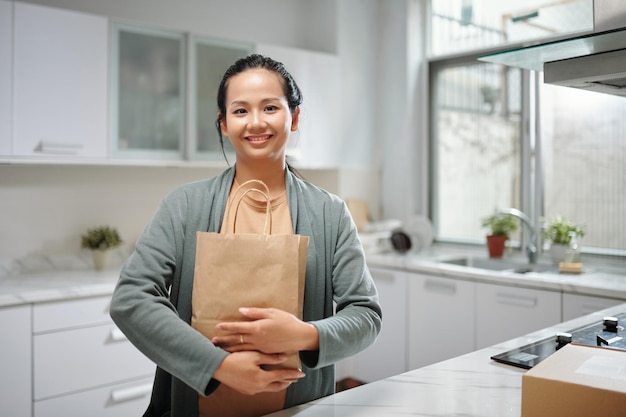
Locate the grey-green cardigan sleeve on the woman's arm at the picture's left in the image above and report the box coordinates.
[110,184,227,395]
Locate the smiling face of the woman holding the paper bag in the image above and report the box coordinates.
[220,68,300,162]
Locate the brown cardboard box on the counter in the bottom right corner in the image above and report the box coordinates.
[522,343,626,417]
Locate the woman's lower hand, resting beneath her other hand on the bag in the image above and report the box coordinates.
[213,351,305,395]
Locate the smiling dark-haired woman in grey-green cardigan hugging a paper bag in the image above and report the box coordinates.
[111,54,382,416]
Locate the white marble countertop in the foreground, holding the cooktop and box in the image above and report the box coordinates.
[268,303,626,417]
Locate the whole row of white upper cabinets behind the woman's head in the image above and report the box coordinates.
[0,0,341,169]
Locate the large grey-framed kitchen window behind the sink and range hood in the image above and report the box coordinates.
[429,0,626,256]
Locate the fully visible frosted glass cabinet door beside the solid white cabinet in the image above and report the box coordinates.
[111,25,185,159]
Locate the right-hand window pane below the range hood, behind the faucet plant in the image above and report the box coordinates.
[540,84,626,255]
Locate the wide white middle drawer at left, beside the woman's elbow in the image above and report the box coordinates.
[33,324,155,400]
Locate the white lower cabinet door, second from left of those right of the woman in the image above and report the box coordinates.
[407,273,475,369]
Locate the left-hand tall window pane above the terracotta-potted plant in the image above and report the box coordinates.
[433,63,521,243]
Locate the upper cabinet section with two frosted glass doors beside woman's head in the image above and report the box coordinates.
[111,24,252,160]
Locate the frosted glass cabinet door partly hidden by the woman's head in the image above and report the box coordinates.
[191,39,252,163]
